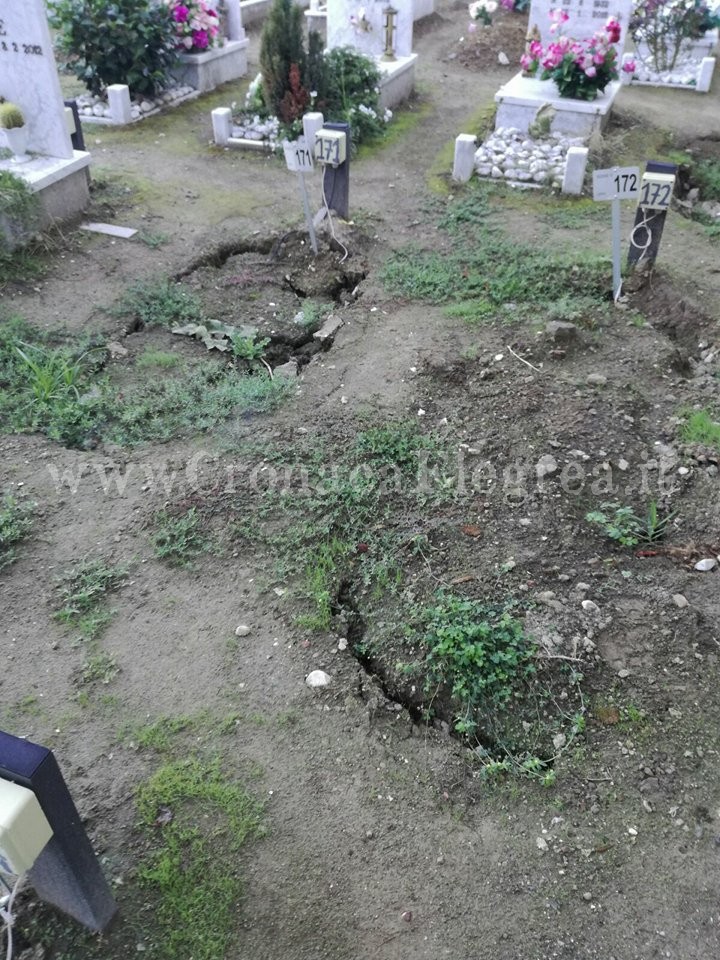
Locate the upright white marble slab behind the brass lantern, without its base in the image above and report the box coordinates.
[328,0,415,57]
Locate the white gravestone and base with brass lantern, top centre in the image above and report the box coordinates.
[327,0,417,109]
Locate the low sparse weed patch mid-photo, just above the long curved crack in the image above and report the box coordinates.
[236,421,452,630]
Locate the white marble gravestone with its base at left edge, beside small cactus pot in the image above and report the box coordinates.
[0,0,90,234]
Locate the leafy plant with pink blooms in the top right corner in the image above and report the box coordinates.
[630,0,720,71]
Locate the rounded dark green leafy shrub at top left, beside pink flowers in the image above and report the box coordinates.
[50,0,177,96]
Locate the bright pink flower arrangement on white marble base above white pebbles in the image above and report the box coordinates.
[520,10,635,100]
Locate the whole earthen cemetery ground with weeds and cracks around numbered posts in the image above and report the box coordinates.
[0,4,720,960]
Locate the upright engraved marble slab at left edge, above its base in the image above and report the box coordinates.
[0,0,73,159]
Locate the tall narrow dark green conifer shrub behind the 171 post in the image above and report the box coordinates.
[260,0,305,117]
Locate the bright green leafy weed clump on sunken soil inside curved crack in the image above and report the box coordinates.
[396,591,585,786]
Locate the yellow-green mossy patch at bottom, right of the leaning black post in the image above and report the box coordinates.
[137,760,262,960]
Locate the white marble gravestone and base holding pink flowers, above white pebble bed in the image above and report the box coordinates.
[495,0,633,137]
